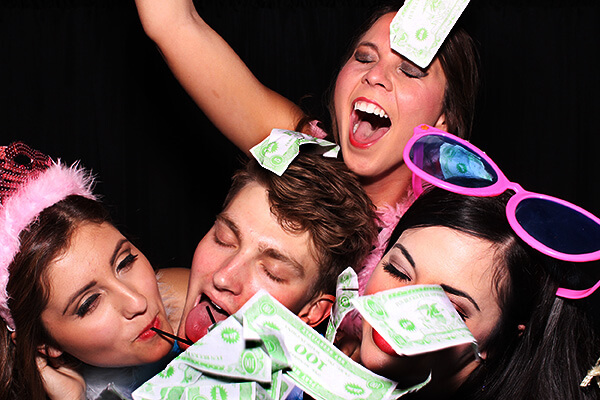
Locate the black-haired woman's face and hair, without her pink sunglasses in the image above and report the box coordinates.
[354,188,600,400]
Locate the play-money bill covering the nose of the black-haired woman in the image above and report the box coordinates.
[353,285,476,355]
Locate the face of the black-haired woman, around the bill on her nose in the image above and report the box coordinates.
[360,227,501,391]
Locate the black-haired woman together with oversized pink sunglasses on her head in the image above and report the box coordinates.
[338,125,600,399]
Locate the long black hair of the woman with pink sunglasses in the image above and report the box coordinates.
[389,188,600,400]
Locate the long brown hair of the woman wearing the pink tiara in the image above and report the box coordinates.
[0,196,109,399]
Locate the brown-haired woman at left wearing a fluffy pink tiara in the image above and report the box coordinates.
[0,143,187,399]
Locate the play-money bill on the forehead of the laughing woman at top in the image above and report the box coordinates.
[390,0,469,68]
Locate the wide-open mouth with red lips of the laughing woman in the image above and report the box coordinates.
[350,100,392,148]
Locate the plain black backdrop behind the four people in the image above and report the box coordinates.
[0,0,600,296]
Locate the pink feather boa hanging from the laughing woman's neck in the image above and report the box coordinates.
[339,198,414,338]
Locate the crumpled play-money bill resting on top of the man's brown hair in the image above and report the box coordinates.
[250,129,340,176]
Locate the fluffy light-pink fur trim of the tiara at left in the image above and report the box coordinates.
[0,160,94,329]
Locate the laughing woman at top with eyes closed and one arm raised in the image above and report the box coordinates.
[136,0,479,308]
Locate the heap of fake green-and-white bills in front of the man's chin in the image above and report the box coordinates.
[133,291,396,400]
